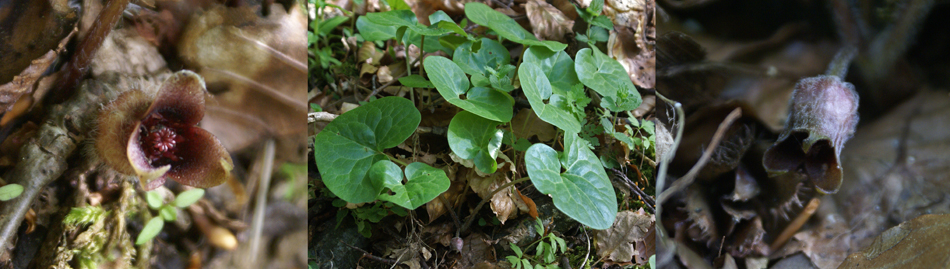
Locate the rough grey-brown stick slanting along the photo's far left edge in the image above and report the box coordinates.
[0,81,105,253]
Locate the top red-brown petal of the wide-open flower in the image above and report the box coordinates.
[148,70,206,126]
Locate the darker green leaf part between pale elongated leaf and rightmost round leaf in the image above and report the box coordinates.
[524,47,581,92]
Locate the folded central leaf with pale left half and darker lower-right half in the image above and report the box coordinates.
[423,56,515,122]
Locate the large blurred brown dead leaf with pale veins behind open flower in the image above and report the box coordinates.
[178,5,307,151]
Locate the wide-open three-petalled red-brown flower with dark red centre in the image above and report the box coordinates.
[95,70,234,190]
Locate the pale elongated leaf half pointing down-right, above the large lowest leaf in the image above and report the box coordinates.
[518,61,581,134]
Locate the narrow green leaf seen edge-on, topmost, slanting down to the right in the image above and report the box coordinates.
[465,2,567,51]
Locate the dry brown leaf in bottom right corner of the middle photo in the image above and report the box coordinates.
[593,210,656,265]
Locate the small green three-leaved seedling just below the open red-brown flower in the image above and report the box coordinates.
[135,189,205,245]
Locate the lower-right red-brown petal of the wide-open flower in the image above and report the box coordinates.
[165,127,234,188]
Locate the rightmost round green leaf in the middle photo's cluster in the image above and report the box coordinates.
[574,48,641,112]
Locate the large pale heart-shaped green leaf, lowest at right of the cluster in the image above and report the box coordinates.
[525,135,617,227]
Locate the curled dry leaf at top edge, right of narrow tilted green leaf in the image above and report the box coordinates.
[524,0,574,42]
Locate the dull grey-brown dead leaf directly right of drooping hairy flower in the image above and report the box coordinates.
[832,90,950,250]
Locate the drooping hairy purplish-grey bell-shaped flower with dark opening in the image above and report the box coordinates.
[762,75,858,194]
